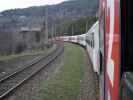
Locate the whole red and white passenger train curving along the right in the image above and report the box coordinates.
[57,0,133,100]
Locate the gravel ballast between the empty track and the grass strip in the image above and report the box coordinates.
[5,45,61,100]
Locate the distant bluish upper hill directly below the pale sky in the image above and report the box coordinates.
[0,0,98,26]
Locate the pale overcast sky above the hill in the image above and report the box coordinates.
[0,0,66,11]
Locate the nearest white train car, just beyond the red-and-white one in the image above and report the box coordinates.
[86,21,100,74]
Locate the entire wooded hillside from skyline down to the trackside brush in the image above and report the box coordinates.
[0,0,99,54]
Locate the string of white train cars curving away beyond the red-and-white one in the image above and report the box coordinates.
[56,21,100,73]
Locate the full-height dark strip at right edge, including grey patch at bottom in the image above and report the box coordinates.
[121,0,133,100]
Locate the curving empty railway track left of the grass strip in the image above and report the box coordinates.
[0,45,63,100]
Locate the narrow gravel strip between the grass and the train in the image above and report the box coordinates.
[78,50,99,100]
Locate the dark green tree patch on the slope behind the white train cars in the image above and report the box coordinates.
[57,16,98,36]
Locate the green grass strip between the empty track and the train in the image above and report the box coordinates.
[40,44,85,100]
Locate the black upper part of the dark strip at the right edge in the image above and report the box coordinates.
[121,0,133,72]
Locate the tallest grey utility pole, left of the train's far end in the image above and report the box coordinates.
[45,7,48,45]
